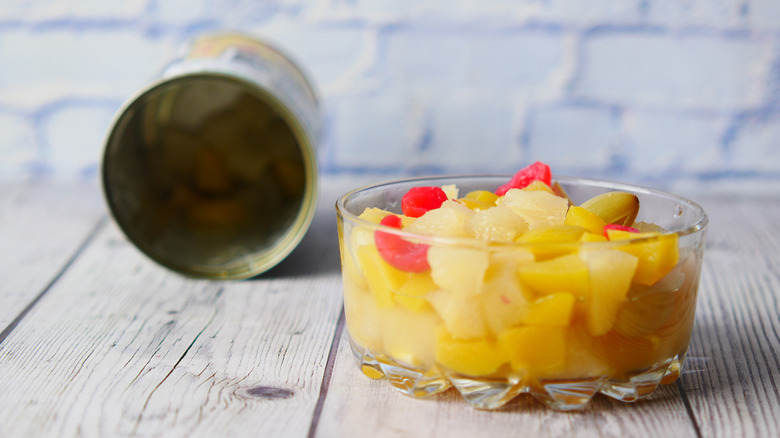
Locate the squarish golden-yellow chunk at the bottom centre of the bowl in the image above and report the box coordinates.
[498,326,566,379]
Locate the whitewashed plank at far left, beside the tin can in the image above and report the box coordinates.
[0,181,106,331]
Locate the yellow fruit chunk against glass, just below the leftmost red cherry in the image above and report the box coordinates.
[357,245,409,309]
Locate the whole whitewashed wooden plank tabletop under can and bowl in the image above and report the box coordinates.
[0,178,780,438]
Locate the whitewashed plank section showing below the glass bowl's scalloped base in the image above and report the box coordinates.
[316,339,695,437]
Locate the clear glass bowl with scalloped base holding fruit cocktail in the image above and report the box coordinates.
[336,175,707,410]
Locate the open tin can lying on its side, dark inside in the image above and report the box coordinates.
[101,34,321,279]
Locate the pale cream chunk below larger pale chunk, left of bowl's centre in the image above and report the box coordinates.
[426,291,488,339]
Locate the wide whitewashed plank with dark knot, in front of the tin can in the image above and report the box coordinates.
[0,176,350,437]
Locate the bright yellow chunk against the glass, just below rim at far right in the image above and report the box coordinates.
[607,230,680,285]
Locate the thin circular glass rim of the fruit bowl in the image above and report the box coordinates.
[335,173,709,249]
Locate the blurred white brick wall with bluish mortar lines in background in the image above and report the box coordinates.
[0,0,780,193]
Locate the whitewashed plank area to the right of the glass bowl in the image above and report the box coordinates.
[681,198,780,437]
